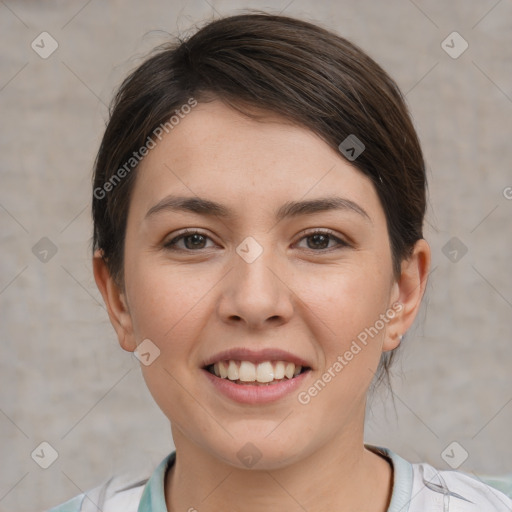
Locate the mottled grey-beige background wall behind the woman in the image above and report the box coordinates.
[0,0,512,512]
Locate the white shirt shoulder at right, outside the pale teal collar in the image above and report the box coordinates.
[410,463,512,512]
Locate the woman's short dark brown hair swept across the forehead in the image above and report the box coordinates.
[92,13,427,386]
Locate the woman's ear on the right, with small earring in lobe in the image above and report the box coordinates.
[382,238,430,351]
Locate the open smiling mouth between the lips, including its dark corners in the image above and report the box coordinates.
[203,359,311,386]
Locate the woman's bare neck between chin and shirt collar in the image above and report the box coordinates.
[165,418,392,512]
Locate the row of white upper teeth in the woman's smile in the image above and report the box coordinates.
[209,360,302,384]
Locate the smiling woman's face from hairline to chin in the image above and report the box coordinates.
[96,101,424,469]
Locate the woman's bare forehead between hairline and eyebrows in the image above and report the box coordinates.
[131,101,383,225]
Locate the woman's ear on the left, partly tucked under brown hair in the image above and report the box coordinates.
[92,250,137,352]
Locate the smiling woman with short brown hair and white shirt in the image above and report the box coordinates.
[49,10,512,512]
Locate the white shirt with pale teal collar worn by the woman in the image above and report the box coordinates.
[48,445,512,512]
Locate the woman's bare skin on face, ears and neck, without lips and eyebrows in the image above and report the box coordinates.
[94,101,430,512]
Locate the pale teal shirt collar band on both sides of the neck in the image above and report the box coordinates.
[137,445,413,512]
